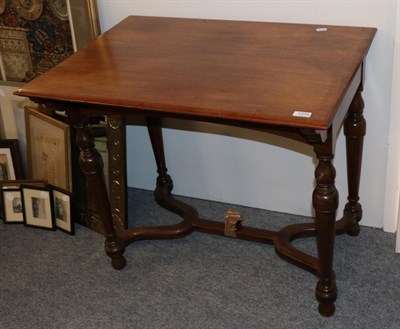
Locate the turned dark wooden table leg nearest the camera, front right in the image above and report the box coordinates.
[313,138,339,316]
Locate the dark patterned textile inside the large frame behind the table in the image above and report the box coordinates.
[0,0,73,82]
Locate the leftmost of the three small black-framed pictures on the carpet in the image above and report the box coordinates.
[1,188,24,224]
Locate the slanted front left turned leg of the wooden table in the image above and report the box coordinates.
[74,118,126,270]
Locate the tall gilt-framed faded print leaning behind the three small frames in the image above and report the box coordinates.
[25,107,72,192]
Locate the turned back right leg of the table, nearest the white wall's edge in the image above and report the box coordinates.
[344,87,366,235]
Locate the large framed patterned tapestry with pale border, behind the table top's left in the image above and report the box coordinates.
[0,0,100,82]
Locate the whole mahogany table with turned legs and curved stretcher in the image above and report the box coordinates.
[16,16,376,316]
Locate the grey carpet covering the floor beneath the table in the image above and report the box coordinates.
[0,189,400,329]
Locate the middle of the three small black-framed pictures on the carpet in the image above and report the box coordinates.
[21,185,55,230]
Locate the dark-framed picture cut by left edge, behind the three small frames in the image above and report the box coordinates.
[0,139,23,181]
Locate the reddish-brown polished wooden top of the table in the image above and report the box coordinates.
[17,16,376,129]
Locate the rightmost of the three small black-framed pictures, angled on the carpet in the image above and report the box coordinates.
[49,185,75,235]
